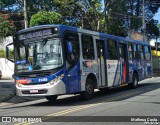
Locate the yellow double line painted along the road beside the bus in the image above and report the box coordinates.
[15,91,142,125]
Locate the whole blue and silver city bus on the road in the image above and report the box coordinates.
[6,25,153,101]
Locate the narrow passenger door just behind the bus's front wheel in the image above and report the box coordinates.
[96,39,107,86]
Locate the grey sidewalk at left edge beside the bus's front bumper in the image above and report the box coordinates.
[0,79,44,107]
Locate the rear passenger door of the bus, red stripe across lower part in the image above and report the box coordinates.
[119,43,129,84]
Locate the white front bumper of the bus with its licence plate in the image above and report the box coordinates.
[16,80,66,96]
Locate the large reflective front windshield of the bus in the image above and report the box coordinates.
[15,39,63,72]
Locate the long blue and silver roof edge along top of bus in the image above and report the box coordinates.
[16,24,149,45]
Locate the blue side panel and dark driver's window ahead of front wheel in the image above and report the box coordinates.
[64,32,81,93]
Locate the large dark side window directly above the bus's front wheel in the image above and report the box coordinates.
[82,34,95,59]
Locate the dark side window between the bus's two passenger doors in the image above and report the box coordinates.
[107,39,118,60]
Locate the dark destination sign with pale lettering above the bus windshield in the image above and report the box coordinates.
[19,29,52,40]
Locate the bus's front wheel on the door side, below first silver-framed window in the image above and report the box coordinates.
[81,79,94,100]
